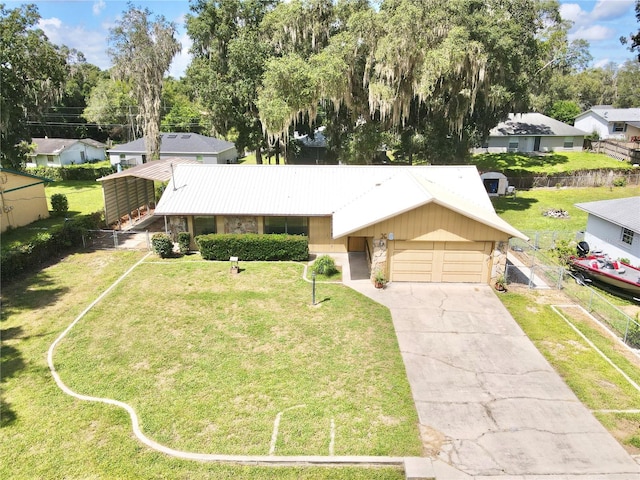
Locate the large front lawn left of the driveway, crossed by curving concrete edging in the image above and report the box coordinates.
[0,252,420,480]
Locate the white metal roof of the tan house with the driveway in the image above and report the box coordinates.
[155,164,526,238]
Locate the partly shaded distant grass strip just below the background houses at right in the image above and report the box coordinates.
[471,151,633,175]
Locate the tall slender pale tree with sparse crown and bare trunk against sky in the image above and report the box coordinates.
[109,4,181,160]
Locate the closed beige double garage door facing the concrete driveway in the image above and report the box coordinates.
[391,241,491,283]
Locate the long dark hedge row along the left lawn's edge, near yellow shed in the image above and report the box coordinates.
[0,212,102,282]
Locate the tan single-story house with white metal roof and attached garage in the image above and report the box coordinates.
[155,165,526,283]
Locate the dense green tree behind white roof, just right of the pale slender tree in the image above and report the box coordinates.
[186,0,275,163]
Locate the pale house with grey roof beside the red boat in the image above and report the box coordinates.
[576,197,640,265]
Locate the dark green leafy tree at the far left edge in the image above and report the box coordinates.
[0,4,68,168]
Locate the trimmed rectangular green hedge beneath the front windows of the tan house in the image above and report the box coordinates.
[195,233,309,262]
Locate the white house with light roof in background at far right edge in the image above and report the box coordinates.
[574,105,640,141]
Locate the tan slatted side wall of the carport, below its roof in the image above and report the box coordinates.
[102,177,155,225]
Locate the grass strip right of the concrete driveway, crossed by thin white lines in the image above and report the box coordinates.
[500,292,640,453]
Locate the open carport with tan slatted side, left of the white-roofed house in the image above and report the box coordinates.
[98,157,198,226]
